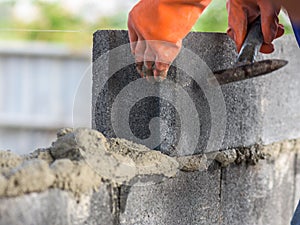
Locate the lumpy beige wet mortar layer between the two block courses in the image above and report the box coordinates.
[0,128,300,197]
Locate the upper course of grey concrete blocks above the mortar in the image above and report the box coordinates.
[92,31,300,155]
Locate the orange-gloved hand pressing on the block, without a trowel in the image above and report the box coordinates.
[128,0,210,81]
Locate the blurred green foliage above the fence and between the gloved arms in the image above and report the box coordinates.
[0,0,292,48]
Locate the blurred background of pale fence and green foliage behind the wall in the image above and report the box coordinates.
[0,0,291,154]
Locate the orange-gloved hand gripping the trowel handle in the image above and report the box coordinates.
[226,0,284,53]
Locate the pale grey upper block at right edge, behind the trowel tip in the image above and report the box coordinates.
[254,35,300,145]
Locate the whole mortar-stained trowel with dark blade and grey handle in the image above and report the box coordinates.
[210,17,288,85]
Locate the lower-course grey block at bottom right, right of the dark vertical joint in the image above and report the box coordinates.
[221,152,296,225]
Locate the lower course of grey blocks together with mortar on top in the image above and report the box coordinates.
[0,128,300,225]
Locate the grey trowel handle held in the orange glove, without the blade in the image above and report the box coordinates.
[237,16,264,64]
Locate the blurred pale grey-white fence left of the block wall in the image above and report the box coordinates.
[0,43,91,154]
